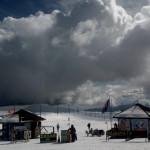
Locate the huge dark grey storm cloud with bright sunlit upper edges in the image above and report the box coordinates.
[0,0,150,105]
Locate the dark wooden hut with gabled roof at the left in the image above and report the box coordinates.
[0,109,45,140]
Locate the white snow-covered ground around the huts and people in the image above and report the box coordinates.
[0,113,150,150]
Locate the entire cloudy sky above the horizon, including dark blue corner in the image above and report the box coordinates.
[0,0,150,106]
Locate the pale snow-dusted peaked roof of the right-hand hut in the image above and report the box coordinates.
[113,104,150,119]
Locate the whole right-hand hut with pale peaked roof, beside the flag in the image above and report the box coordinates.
[107,104,150,140]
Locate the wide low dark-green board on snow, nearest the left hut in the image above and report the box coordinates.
[40,133,57,143]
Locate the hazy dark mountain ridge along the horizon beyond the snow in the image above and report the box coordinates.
[0,103,150,113]
